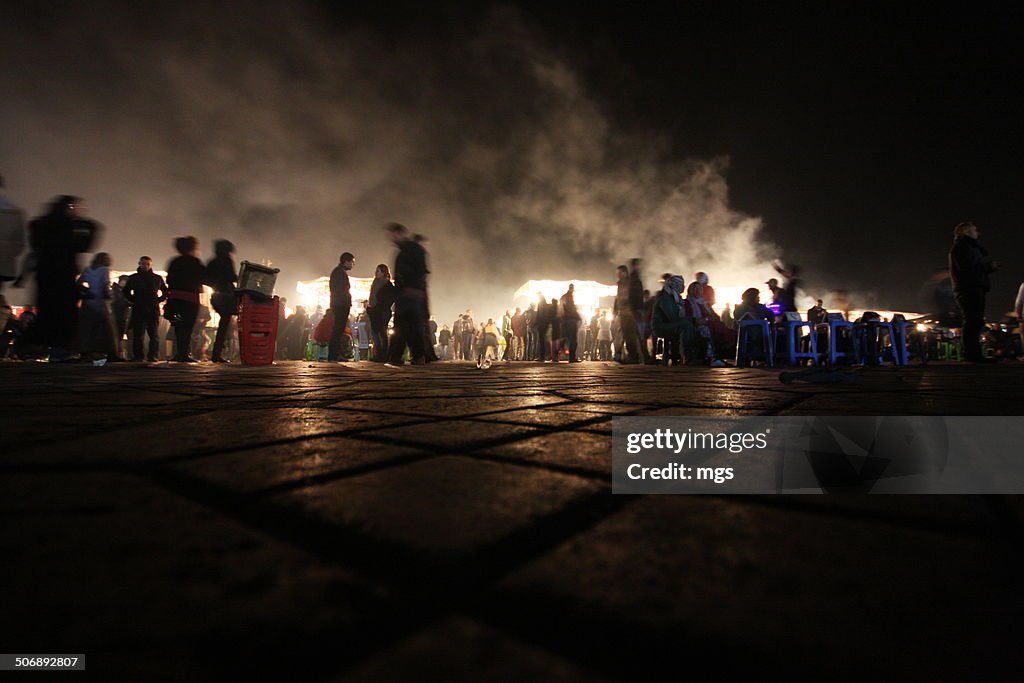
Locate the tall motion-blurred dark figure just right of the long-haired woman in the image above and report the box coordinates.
[387,223,430,365]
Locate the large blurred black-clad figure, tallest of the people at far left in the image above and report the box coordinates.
[29,195,99,361]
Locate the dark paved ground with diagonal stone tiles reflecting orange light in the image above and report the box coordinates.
[0,362,1024,681]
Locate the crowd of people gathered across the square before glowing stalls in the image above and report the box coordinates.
[0,177,1024,367]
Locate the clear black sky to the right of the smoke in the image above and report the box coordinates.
[337,2,1024,313]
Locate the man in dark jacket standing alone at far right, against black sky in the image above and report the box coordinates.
[949,222,997,362]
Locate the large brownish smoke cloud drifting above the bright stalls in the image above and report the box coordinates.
[0,2,778,321]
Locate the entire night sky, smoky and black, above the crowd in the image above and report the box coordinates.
[0,2,1024,315]
